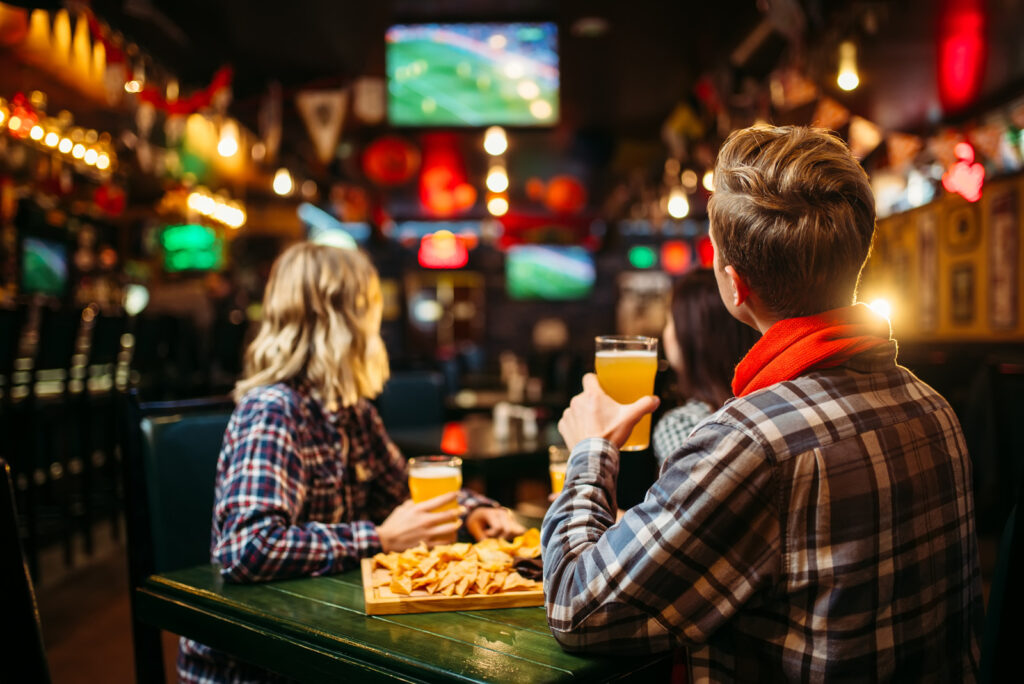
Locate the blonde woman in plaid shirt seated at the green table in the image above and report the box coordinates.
[178,243,522,683]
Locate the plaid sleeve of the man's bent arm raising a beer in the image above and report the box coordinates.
[542,424,780,653]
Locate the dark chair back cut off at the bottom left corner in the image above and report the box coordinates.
[0,459,50,682]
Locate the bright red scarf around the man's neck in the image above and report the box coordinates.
[732,304,890,396]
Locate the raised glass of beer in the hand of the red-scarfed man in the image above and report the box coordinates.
[594,335,657,452]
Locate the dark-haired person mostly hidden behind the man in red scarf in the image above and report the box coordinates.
[651,268,757,466]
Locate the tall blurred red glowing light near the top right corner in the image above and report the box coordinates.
[938,0,988,112]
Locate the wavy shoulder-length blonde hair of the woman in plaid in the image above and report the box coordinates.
[233,243,388,410]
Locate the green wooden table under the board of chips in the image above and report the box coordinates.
[135,565,669,683]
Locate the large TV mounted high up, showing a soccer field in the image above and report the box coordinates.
[386,23,558,126]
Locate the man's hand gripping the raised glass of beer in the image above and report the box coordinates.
[558,373,660,450]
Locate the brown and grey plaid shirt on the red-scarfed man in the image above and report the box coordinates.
[543,342,983,682]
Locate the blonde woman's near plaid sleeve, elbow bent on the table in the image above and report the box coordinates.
[212,393,380,582]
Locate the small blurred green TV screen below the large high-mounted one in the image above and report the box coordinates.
[505,245,595,301]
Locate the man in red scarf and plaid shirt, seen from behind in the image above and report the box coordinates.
[542,127,983,682]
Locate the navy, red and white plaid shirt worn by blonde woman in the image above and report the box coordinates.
[178,384,497,684]
